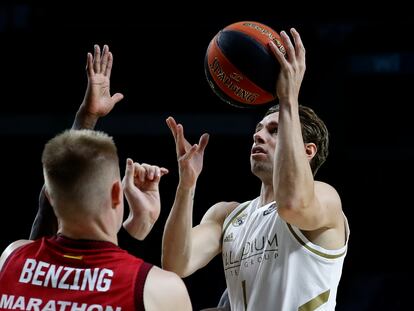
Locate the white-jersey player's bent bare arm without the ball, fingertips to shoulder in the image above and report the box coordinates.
[162,117,234,277]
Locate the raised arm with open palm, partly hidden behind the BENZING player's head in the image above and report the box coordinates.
[30,45,123,240]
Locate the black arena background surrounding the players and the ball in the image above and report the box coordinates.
[0,1,414,311]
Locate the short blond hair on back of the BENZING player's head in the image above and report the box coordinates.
[42,129,120,214]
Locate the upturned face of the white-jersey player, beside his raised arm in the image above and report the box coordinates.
[250,112,279,177]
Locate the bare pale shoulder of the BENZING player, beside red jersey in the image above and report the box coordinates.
[144,266,192,311]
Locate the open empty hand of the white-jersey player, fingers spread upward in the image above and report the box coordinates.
[166,117,209,188]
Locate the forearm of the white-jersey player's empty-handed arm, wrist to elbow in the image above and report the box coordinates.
[162,186,195,276]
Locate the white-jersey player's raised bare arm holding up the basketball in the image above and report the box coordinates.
[271,29,344,234]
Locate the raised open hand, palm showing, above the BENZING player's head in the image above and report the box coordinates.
[82,45,124,118]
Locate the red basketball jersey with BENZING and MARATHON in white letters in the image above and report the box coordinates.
[0,236,152,311]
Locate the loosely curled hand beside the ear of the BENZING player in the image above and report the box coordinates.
[122,159,168,240]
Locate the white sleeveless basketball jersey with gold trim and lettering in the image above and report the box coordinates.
[222,198,349,311]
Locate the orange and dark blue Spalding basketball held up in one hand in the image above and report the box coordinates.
[204,21,285,107]
